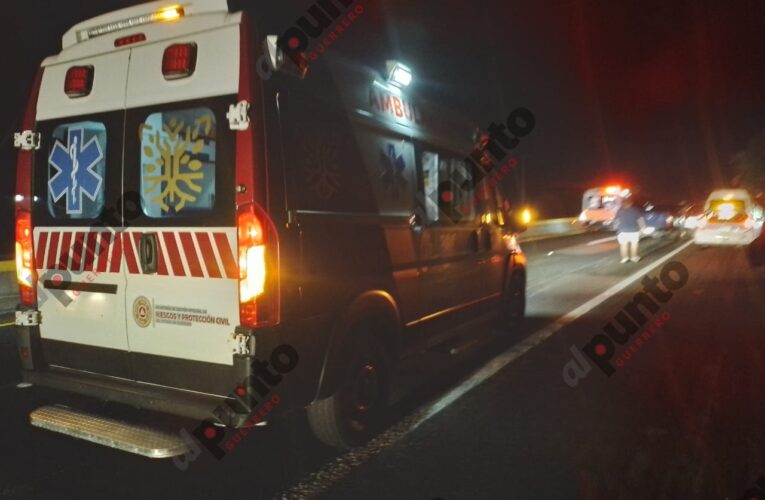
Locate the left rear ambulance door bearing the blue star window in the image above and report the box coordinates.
[32,51,131,378]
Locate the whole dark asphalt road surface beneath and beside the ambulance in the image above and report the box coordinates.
[0,231,765,500]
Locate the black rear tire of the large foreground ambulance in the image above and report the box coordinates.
[308,335,391,449]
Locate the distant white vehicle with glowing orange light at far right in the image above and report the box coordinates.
[693,189,763,246]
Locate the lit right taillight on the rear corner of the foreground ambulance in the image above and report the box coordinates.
[237,208,279,328]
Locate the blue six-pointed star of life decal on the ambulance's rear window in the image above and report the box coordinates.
[48,128,104,214]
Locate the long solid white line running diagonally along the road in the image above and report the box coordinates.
[276,241,693,500]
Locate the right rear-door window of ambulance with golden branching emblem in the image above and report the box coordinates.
[139,108,216,218]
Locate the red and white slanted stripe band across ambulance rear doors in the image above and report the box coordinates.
[35,230,239,279]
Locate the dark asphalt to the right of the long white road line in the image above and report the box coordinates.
[302,241,765,500]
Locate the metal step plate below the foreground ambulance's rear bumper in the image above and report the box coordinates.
[29,405,189,458]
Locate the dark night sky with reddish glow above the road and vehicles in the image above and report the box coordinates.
[0,0,765,254]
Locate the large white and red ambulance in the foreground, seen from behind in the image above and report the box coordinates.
[15,0,526,457]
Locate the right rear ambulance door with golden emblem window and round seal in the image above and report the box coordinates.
[123,24,240,394]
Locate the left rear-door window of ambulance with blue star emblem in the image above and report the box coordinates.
[47,121,106,219]
